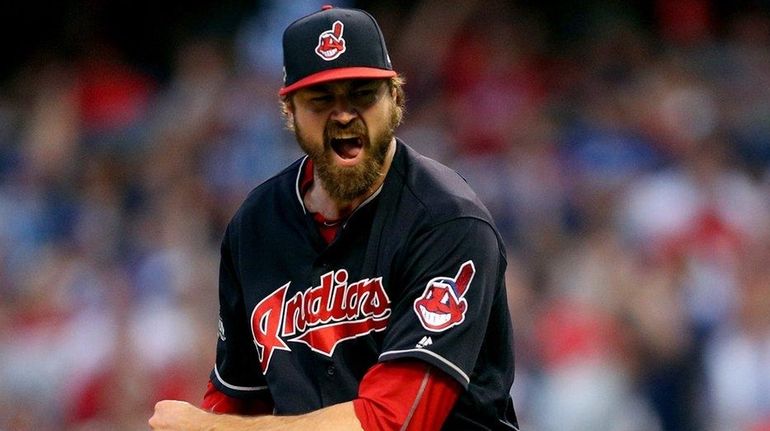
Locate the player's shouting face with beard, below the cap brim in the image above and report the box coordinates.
[292,79,398,202]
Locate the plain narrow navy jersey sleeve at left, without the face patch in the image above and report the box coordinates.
[210,225,271,401]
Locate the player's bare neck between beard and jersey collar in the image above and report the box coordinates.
[304,138,396,220]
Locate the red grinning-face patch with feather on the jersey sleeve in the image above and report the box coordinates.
[414,260,476,332]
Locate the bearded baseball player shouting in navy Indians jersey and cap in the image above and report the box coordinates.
[150,6,518,430]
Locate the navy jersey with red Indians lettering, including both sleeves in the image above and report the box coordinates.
[211,141,516,430]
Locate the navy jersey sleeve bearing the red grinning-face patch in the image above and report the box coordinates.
[379,217,505,388]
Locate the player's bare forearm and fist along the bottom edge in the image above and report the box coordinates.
[150,401,362,431]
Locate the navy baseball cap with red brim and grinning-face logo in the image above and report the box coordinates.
[278,5,396,96]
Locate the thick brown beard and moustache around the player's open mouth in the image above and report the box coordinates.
[294,109,398,203]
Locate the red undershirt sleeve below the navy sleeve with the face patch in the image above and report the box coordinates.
[353,361,462,431]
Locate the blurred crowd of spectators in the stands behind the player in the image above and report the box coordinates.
[0,0,770,431]
